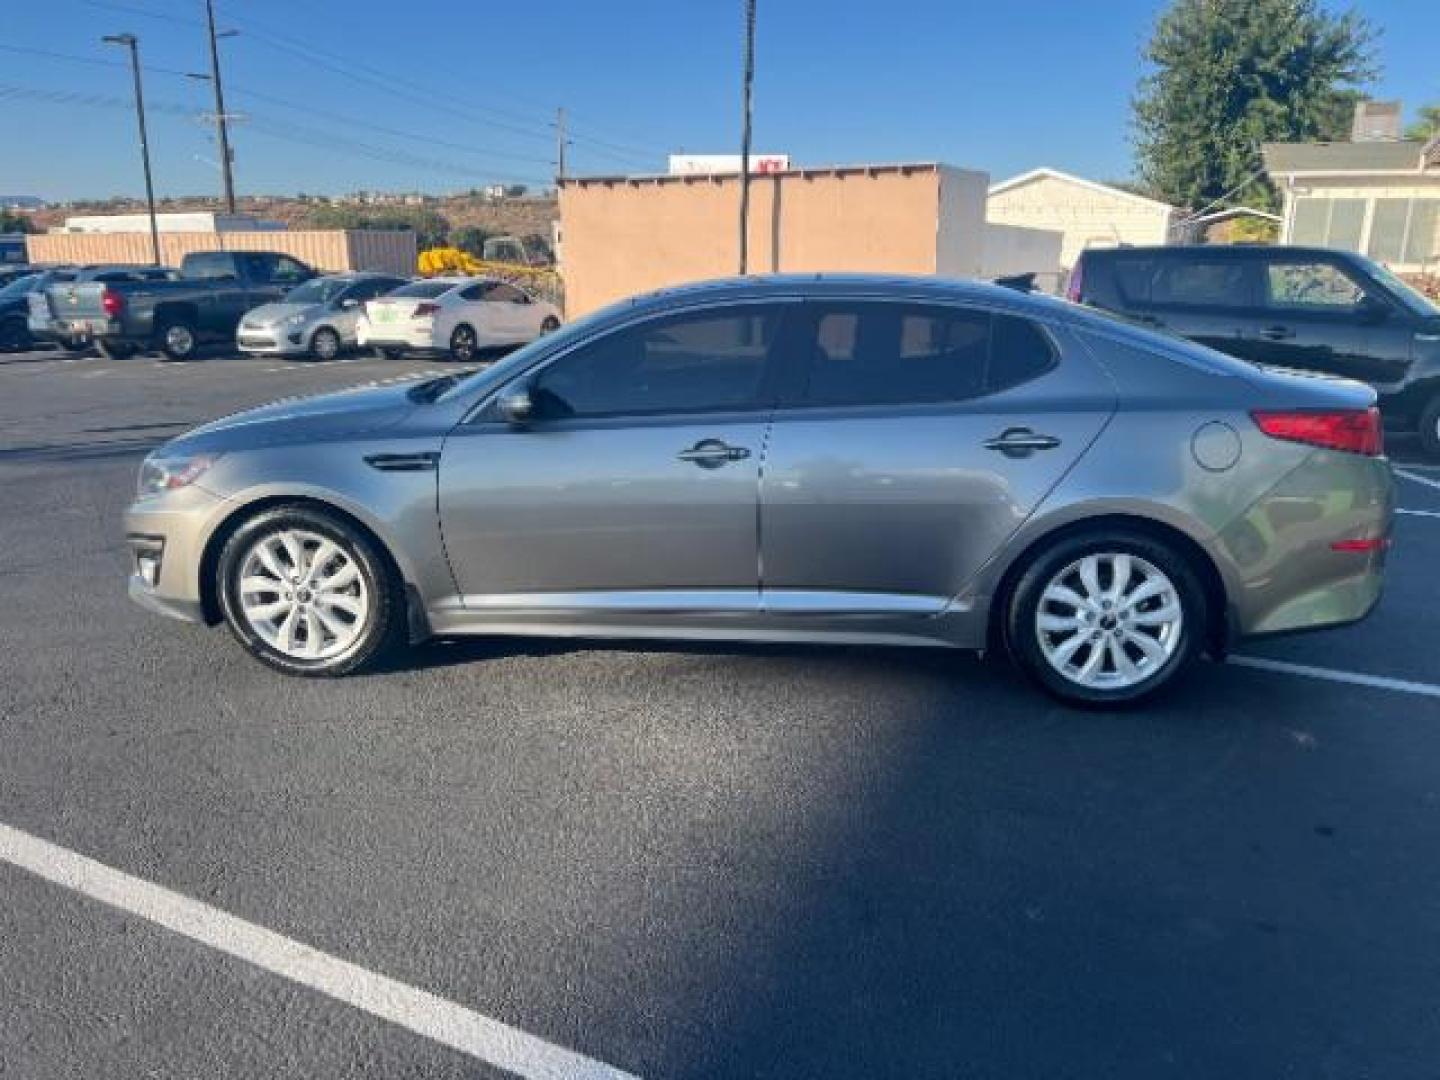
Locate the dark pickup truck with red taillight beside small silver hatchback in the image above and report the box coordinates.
[46,251,315,360]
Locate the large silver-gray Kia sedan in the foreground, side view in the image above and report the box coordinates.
[125,276,1392,706]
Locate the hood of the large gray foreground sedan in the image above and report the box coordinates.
[173,383,416,452]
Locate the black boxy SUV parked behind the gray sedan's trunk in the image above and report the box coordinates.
[1067,246,1440,454]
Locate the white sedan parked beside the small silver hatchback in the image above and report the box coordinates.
[356,278,560,361]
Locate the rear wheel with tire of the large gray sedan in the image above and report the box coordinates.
[1005,530,1207,707]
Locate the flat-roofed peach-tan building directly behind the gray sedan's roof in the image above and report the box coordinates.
[560,164,985,318]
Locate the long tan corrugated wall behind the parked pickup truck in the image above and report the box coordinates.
[26,229,415,275]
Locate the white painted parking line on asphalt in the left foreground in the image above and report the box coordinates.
[0,825,635,1080]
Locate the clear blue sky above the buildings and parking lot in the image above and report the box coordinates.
[0,0,1440,199]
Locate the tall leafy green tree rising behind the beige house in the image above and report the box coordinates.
[1133,0,1377,209]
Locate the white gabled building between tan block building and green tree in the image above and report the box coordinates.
[988,174,1174,271]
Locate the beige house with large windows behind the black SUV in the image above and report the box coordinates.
[1261,138,1440,274]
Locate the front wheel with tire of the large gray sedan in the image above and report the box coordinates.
[216,505,405,675]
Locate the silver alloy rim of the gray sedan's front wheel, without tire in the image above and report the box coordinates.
[236,528,370,660]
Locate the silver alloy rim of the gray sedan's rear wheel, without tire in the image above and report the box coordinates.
[1035,552,1185,690]
